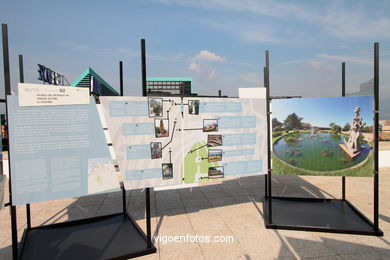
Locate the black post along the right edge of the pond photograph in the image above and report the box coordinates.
[374,42,379,230]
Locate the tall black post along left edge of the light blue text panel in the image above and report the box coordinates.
[1,24,18,260]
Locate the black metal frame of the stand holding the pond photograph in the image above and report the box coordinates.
[263,43,383,236]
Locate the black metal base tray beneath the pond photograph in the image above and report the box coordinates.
[263,197,383,236]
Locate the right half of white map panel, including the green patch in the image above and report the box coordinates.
[182,98,267,183]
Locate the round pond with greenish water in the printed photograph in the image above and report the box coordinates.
[274,133,370,171]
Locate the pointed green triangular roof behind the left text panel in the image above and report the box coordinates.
[70,67,119,96]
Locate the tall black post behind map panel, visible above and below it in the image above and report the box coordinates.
[141,39,152,248]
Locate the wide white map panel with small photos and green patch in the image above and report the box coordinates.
[100,97,266,189]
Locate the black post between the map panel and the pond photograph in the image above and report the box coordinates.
[265,51,272,224]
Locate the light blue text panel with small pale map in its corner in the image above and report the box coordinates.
[7,93,119,205]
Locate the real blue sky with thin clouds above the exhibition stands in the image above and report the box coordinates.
[0,0,390,118]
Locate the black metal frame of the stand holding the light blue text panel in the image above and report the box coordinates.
[2,24,157,260]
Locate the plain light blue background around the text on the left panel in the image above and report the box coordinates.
[7,96,111,205]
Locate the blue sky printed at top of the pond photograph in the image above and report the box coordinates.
[272,96,374,127]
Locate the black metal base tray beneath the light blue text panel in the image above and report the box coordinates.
[20,213,156,260]
